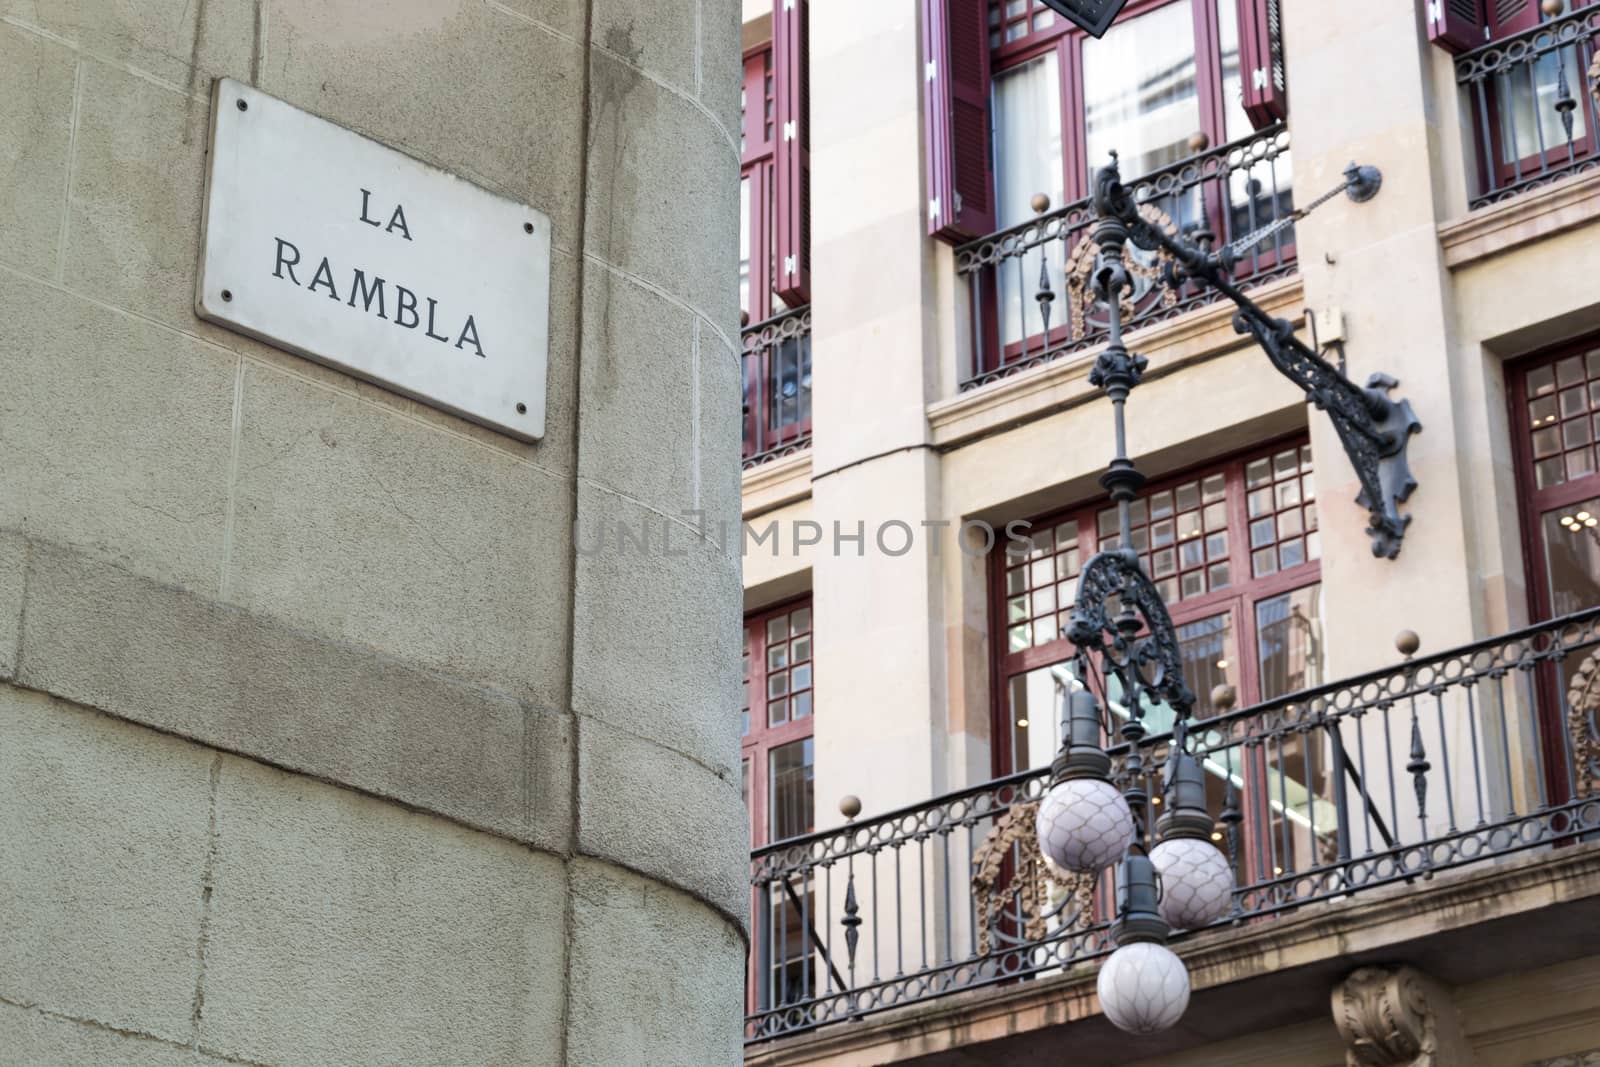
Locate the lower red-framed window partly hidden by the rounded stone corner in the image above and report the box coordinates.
[741,600,816,1009]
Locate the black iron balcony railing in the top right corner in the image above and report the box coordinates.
[1456,6,1600,208]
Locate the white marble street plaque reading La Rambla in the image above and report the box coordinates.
[195,78,550,440]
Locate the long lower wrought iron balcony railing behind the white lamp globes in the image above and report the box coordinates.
[746,608,1600,1043]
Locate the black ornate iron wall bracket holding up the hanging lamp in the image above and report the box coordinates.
[1094,158,1422,560]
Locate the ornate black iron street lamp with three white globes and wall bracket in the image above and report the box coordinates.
[1035,151,1421,1033]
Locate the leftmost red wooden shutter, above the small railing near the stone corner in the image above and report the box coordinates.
[773,0,811,307]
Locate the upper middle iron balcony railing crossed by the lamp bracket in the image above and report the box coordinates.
[955,125,1294,390]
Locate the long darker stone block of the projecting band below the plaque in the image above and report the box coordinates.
[18,544,571,848]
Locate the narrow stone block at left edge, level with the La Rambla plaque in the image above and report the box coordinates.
[0,24,77,278]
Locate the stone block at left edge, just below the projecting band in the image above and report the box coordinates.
[0,685,214,1043]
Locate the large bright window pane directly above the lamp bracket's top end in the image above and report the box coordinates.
[1083,0,1200,178]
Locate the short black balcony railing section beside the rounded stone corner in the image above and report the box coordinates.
[741,300,811,469]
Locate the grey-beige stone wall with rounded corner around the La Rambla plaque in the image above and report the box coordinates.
[0,0,749,1067]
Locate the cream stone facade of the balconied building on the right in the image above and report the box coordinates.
[744,0,1600,1067]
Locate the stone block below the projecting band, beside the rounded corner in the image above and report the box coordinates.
[200,758,565,1067]
